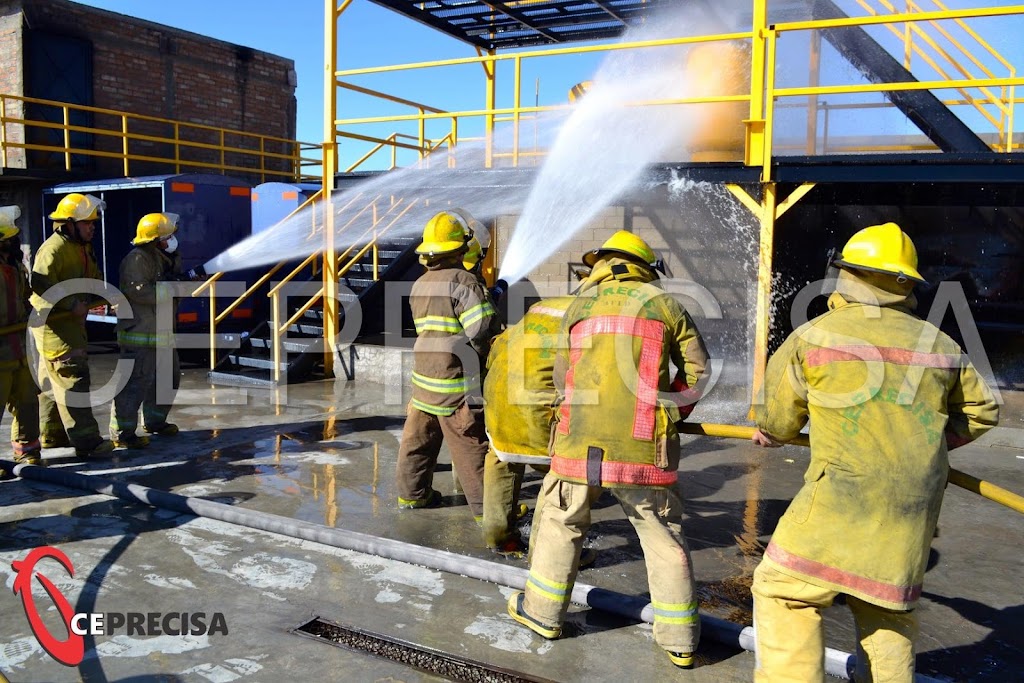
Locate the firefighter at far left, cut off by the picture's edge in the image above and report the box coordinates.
[0,206,43,465]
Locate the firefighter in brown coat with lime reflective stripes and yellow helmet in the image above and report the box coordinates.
[396,210,501,518]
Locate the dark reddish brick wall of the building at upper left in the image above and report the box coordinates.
[0,0,296,181]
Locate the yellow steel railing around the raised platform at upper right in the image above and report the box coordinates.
[327,0,1024,174]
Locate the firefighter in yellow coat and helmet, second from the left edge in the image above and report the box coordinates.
[31,193,114,457]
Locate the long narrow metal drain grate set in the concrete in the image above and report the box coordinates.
[293,616,555,683]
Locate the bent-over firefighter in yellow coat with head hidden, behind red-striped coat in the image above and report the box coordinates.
[483,296,575,557]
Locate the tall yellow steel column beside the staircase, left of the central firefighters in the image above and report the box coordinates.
[322,0,352,377]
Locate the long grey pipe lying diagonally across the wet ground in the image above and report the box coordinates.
[0,460,940,683]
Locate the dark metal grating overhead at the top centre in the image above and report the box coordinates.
[372,0,677,50]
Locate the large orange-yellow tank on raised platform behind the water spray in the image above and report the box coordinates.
[685,42,751,162]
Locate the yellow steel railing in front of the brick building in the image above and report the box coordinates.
[0,94,322,181]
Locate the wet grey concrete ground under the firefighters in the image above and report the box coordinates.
[0,355,1024,683]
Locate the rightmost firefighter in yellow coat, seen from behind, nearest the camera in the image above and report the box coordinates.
[752,223,998,683]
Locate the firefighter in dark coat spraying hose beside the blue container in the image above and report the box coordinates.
[111,213,188,449]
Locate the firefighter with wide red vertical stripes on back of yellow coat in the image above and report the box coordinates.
[508,231,708,667]
